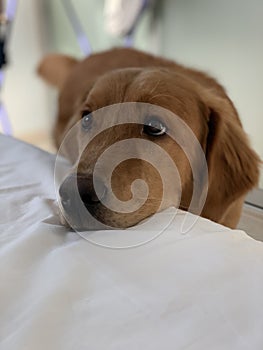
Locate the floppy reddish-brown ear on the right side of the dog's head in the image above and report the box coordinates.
[204,96,260,222]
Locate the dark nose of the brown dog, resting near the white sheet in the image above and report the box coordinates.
[59,174,107,210]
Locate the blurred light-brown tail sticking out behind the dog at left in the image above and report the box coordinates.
[37,54,78,90]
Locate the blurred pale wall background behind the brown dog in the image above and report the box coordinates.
[1,0,263,188]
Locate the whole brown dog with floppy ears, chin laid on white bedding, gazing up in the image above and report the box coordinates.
[39,51,259,229]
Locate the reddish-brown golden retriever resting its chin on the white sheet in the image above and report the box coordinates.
[38,48,260,229]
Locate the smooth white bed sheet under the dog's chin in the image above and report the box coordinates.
[0,135,263,350]
